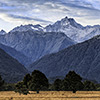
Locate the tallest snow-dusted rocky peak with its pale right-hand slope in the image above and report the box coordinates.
[44,17,100,42]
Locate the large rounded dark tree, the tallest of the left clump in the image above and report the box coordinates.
[29,70,49,93]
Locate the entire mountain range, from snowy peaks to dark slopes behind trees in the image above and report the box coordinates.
[0,17,100,82]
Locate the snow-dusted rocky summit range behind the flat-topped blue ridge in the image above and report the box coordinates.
[10,17,100,43]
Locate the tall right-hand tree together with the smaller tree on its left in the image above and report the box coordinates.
[53,71,84,93]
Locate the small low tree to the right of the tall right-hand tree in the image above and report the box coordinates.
[83,80,96,91]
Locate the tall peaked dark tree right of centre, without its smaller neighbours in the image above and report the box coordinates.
[62,71,84,93]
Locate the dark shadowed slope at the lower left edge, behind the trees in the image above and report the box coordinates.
[0,49,28,83]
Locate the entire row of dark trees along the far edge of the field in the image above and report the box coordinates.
[0,70,100,94]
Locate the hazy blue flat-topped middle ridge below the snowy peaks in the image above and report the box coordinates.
[0,30,75,65]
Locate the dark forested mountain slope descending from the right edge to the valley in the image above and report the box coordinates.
[29,36,100,83]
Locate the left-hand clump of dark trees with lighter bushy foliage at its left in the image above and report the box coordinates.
[15,70,49,94]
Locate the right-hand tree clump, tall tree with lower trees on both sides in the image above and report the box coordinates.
[51,71,97,93]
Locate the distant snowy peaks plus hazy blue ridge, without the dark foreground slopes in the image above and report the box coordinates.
[0,17,100,66]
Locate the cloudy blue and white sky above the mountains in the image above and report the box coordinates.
[0,0,100,31]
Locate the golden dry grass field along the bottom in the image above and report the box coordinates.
[0,91,100,100]
